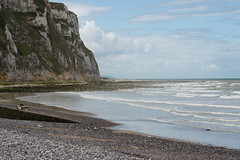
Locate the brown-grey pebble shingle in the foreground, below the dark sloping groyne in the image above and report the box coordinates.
[0,109,240,160]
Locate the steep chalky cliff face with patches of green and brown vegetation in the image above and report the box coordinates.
[0,0,100,81]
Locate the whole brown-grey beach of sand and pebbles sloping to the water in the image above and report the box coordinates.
[0,83,240,160]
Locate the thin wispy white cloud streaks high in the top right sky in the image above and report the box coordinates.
[129,0,240,23]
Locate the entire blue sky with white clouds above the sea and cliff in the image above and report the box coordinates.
[50,0,240,79]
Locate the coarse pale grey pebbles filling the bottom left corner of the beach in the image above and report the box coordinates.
[0,118,143,159]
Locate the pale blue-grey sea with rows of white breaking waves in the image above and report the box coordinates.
[18,79,240,149]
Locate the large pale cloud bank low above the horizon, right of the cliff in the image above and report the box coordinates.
[80,21,240,78]
